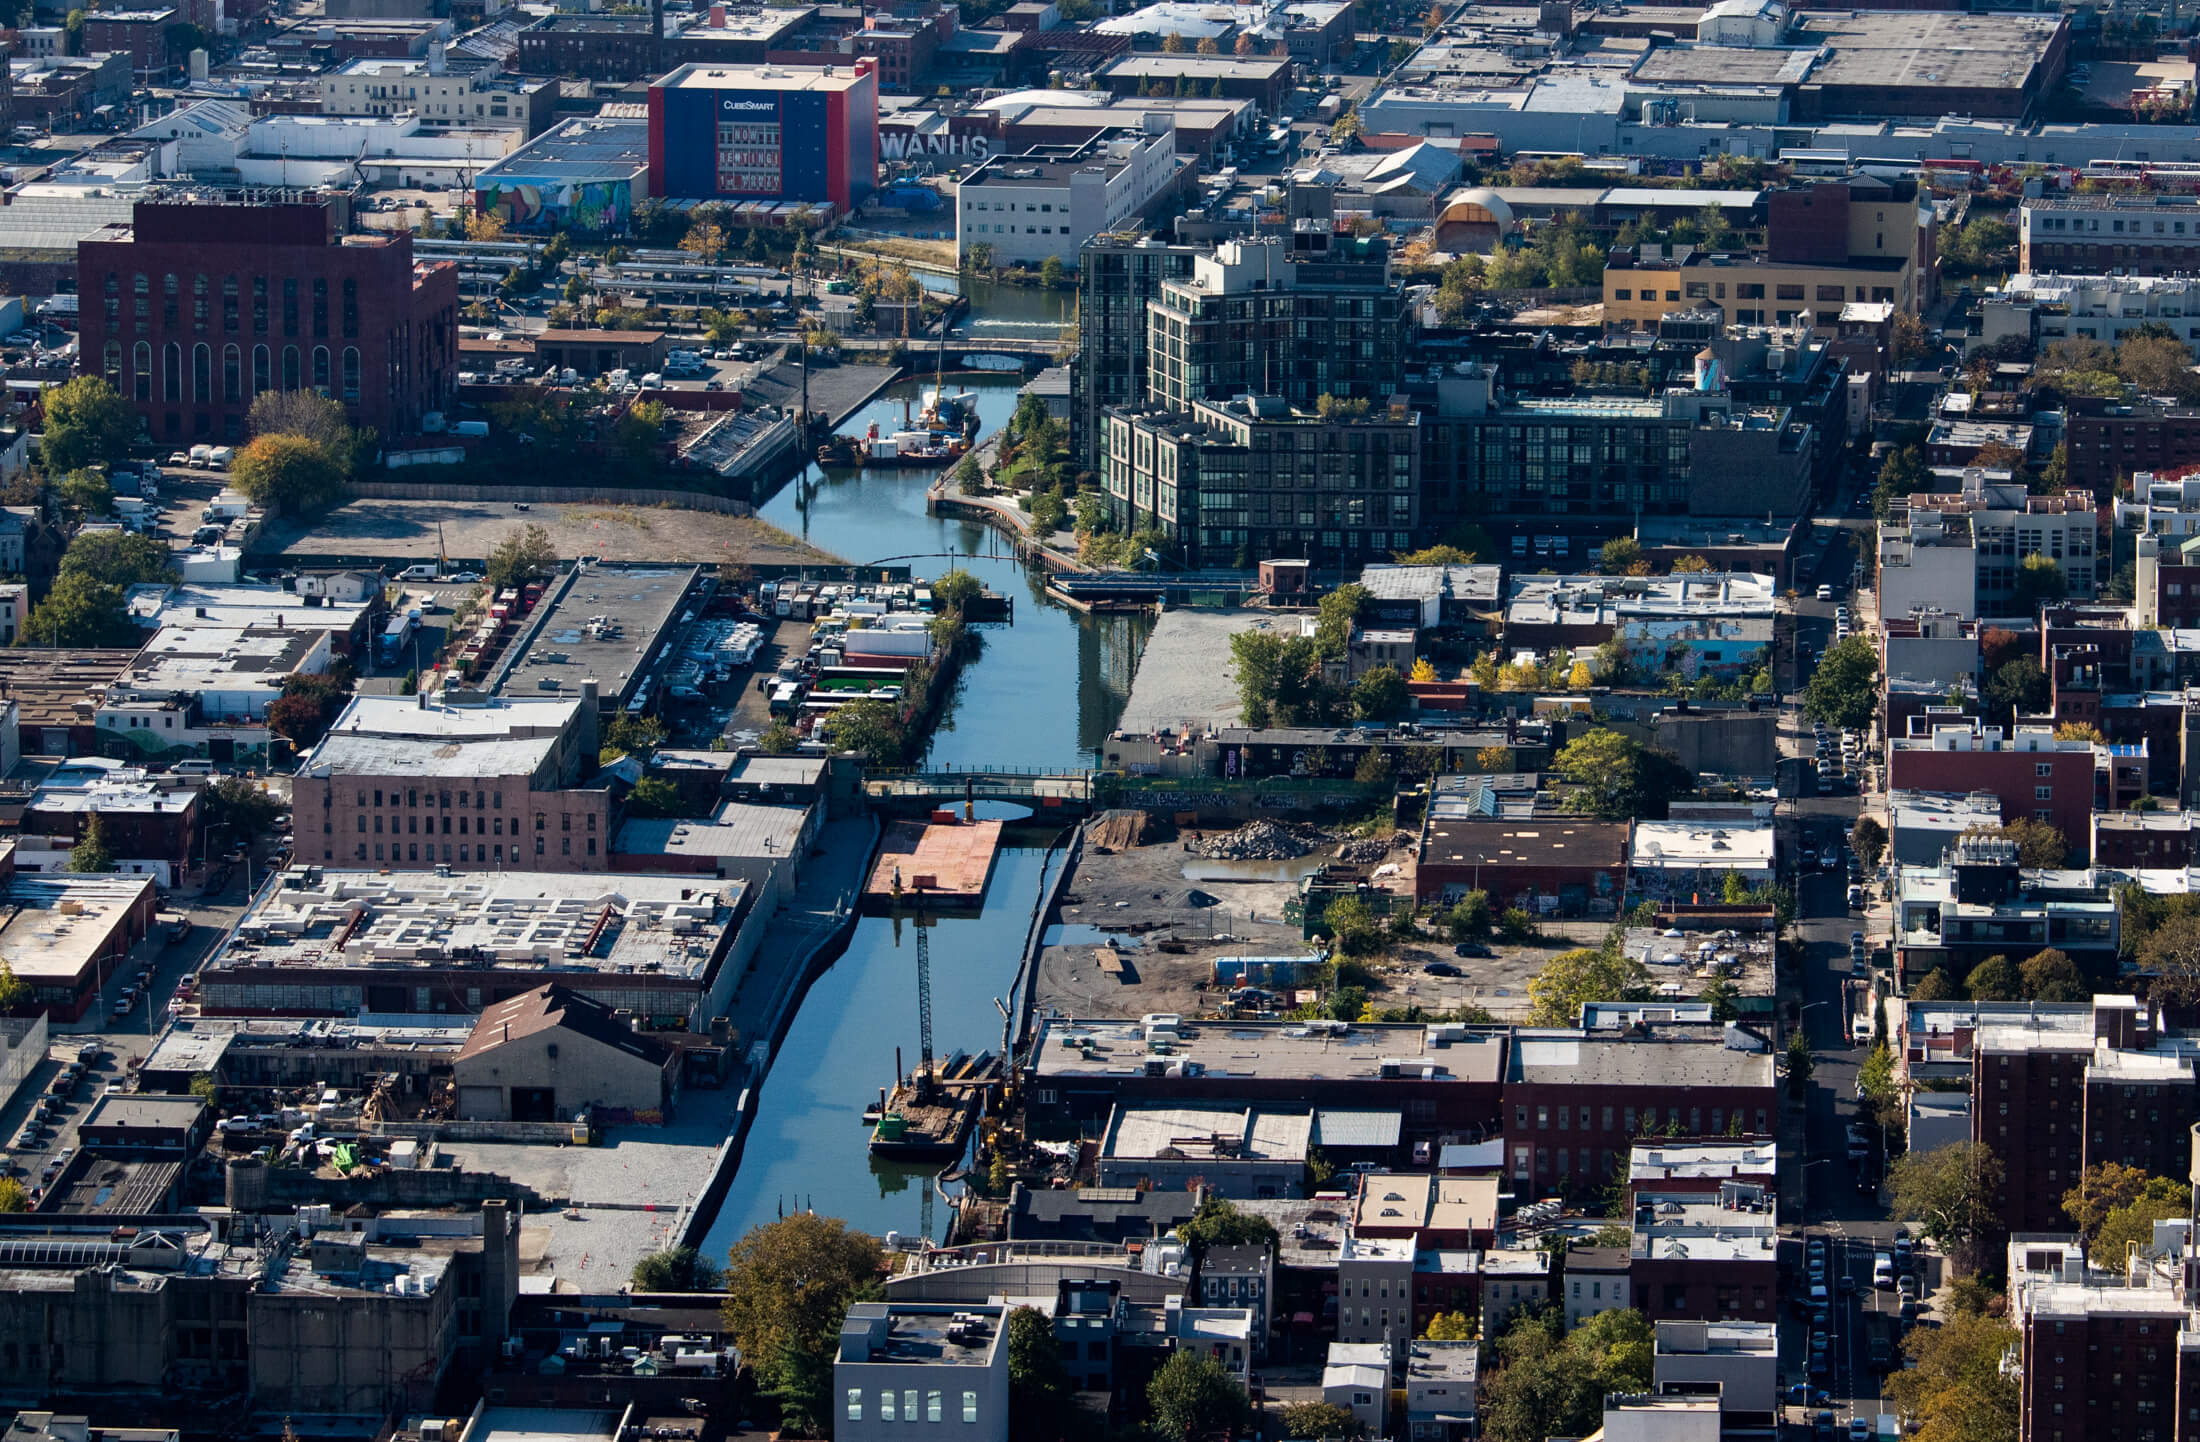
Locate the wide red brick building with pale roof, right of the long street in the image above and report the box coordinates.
[1888,718,2097,856]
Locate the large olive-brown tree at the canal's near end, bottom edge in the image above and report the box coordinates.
[724,1211,887,1387]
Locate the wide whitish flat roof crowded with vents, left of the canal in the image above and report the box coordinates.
[214,867,744,982]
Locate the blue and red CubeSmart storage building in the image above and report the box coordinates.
[649,57,878,211]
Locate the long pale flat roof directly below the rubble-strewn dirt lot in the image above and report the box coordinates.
[1036,1017,1505,1085]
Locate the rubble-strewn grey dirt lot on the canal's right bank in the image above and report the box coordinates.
[1036,810,1606,1019]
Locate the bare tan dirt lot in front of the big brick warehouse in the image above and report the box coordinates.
[251,500,834,566]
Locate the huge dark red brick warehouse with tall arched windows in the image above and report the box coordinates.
[77,198,458,443]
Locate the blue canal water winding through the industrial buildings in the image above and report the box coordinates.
[706,372,1151,1255]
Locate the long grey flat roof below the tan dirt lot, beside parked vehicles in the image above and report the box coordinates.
[497,563,702,704]
